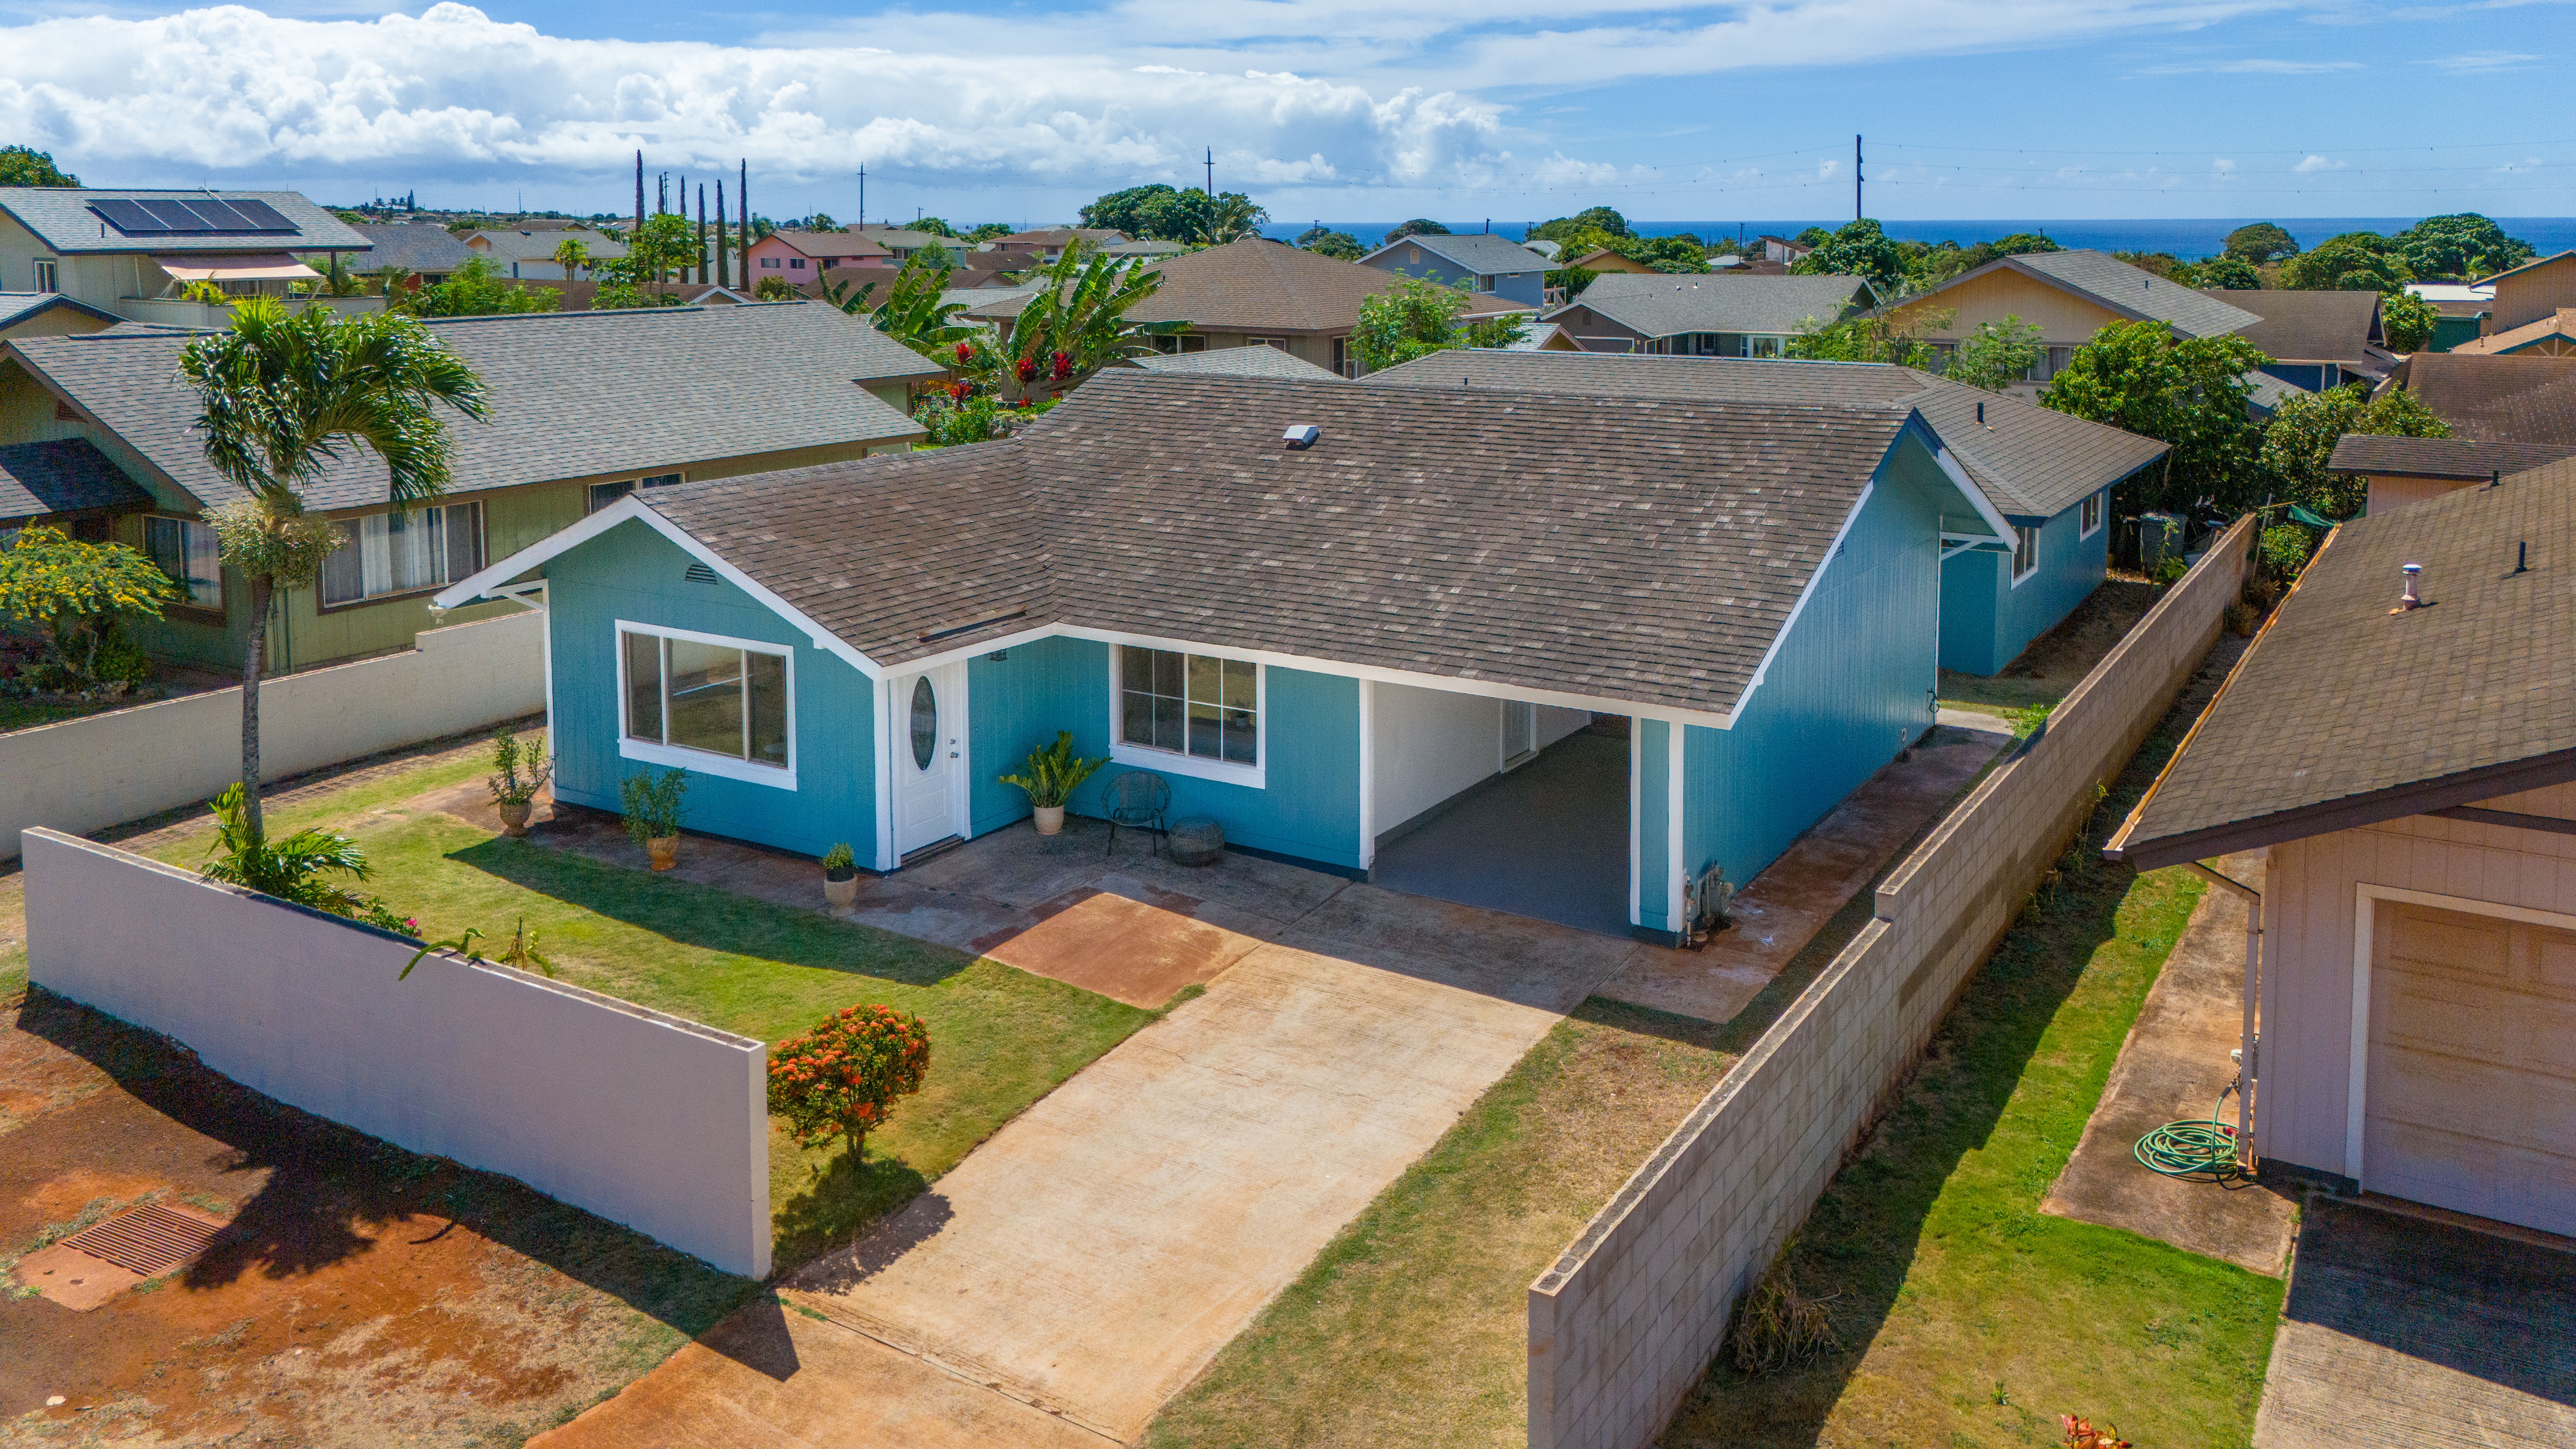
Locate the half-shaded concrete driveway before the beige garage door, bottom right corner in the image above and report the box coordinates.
[2254,1194,2576,1449]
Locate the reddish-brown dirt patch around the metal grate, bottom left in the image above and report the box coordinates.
[0,993,750,1449]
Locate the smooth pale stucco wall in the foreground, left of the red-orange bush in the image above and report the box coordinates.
[26,830,770,1276]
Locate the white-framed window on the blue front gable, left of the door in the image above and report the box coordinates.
[616,619,796,789]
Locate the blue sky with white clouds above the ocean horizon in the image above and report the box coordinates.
[0,0,2576,222]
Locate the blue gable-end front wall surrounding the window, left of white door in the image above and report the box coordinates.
[546,521,876,861]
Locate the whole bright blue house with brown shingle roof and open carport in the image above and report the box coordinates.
[438,366,2007,941]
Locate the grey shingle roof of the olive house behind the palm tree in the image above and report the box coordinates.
[5,302,940,508]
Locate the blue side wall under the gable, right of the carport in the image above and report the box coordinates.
[1679,438,1947,892]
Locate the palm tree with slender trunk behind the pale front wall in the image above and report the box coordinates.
[180,296,489,840]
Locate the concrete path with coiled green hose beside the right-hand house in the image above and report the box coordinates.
[2040,851,2298,1276]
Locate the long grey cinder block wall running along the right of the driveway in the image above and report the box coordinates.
[1530,518,2254,1449]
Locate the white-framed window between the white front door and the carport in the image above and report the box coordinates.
[1110,645,1270,789]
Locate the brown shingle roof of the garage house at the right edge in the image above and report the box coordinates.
[2110,462,2576,869]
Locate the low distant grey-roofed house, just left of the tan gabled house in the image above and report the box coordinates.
[1545,271,1875,358]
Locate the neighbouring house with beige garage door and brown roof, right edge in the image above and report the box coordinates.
[2107,462,2576,1235]
